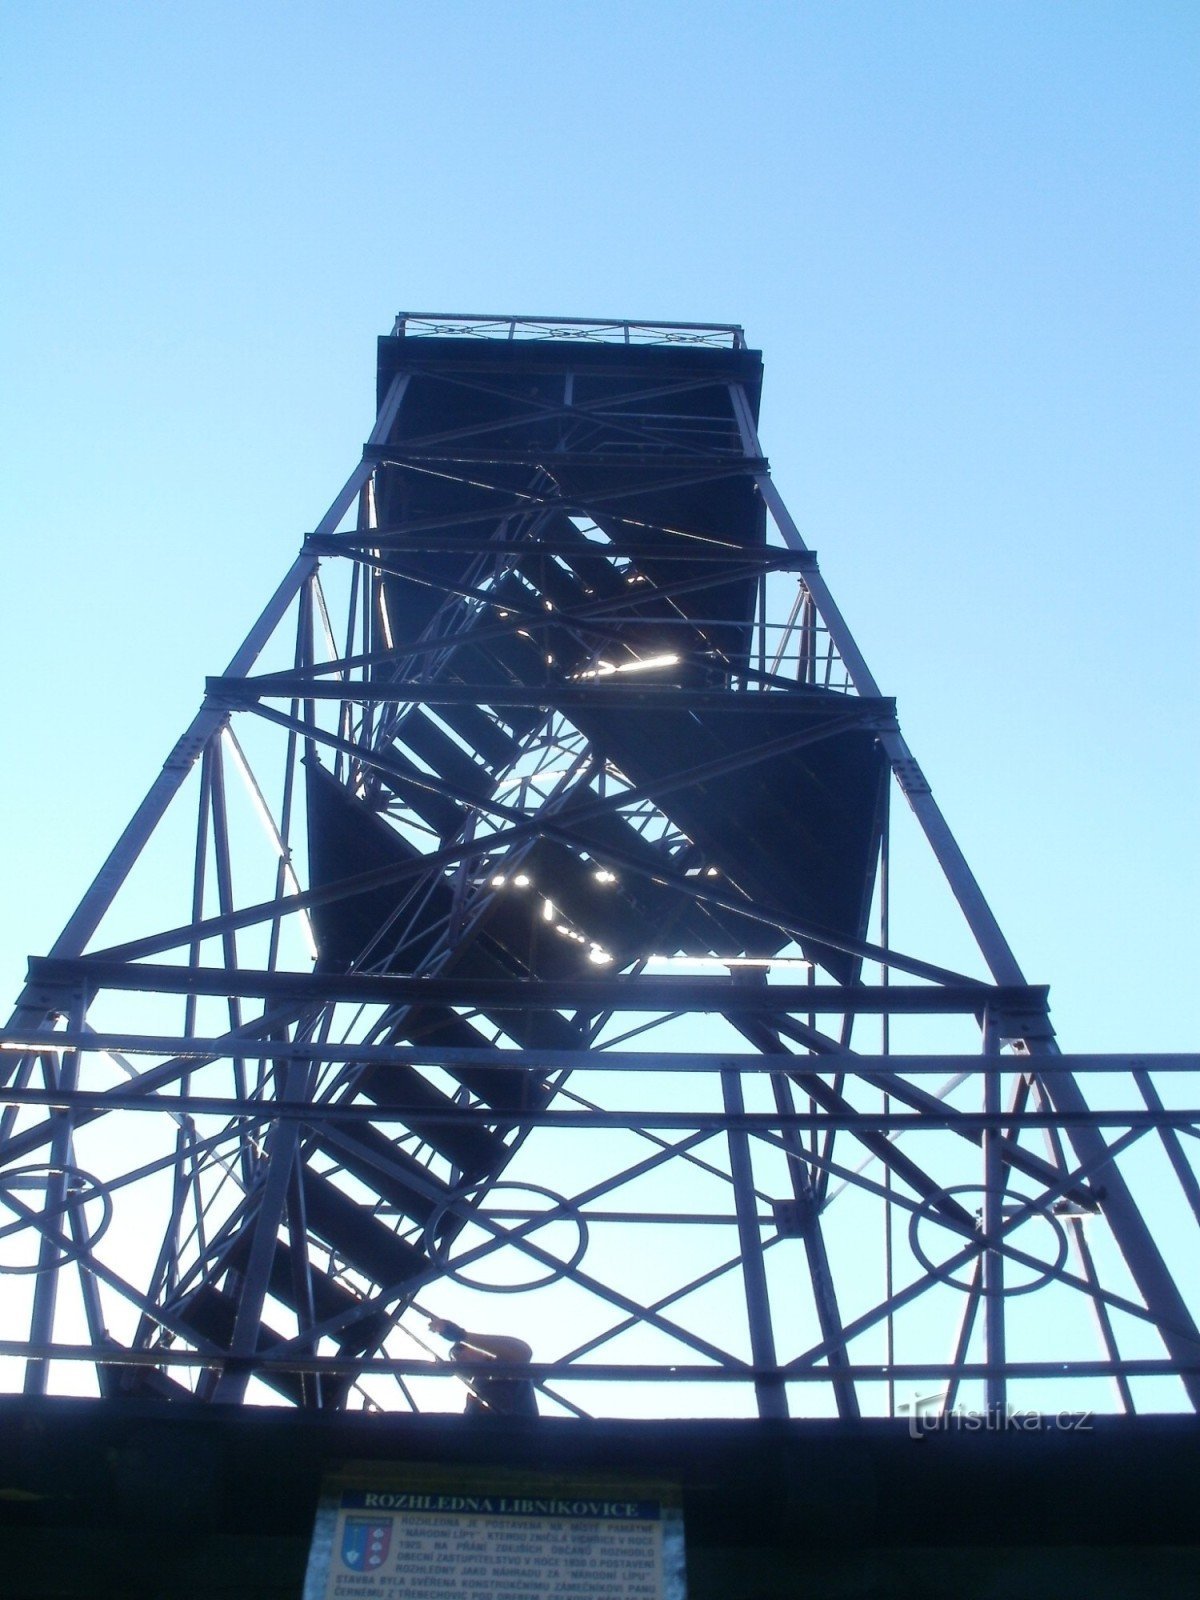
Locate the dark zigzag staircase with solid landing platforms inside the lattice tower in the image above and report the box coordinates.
[143,339,888,1405]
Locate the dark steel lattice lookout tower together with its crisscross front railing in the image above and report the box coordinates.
[0,315,1200,1416]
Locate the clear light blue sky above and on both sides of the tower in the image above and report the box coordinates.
[0,0,1200,1048]
